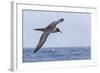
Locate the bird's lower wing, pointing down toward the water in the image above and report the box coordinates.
[34,32,49,53]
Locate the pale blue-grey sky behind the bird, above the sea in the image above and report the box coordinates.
[22,10,91,48]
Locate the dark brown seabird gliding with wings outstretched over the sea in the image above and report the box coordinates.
[34,18,64,53]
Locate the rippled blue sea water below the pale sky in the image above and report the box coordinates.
[23,47,91,63]
